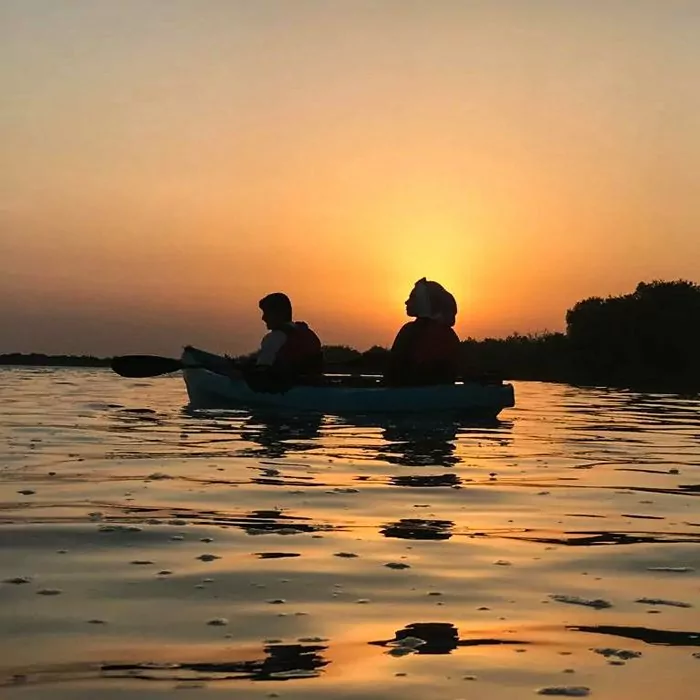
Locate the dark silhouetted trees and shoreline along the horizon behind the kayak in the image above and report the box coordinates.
[0,280,700,393]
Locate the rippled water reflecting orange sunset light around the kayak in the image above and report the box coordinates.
[0,368,700,700]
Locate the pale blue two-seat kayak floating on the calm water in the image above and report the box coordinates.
[182,348,515,417]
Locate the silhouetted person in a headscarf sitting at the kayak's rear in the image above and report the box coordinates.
[384,277,460,386]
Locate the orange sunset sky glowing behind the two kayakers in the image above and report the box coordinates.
[0,0,700,355]
